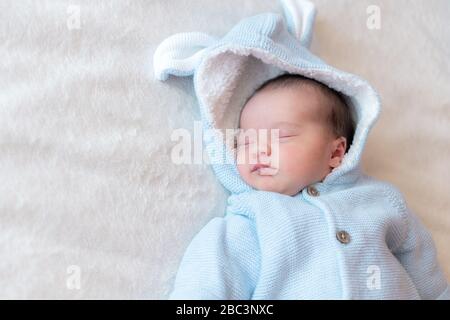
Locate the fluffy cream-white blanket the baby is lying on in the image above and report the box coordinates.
[0,0,450,299]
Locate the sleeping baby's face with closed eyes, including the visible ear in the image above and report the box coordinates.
[237,86,346,196]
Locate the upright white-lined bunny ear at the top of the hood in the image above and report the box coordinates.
[281,0,316,48]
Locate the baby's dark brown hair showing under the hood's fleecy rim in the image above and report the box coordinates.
[243,73,355,152]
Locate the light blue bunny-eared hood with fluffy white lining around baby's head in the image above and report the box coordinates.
[153,0,381,193]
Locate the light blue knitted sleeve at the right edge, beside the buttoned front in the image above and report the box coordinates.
[394,208,450,299]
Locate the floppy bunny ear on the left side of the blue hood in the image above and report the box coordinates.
[153,32,217,81]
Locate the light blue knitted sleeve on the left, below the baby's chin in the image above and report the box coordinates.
[169,214,259,300]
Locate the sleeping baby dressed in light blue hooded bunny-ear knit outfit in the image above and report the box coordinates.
[154,0,450,299]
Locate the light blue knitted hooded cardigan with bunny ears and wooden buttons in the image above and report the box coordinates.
[154,0,450,299]
